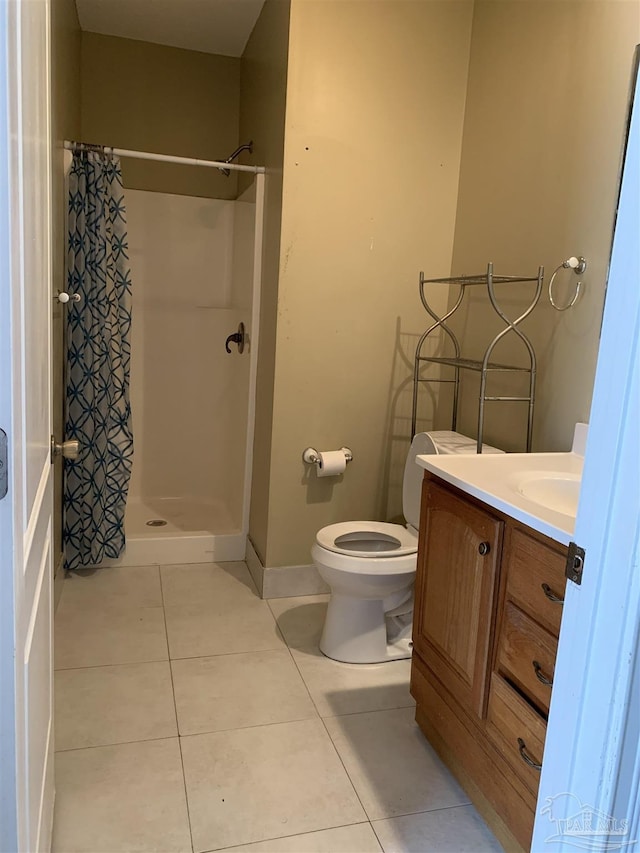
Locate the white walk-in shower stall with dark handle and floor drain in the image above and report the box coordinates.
[63,144,264,566]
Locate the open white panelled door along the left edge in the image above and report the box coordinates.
[0,0,53,853]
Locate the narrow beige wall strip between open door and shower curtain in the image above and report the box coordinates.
[51,0,80,563]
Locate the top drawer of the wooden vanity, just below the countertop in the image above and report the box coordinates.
[503,528,567,637]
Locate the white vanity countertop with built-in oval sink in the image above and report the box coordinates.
[416,453,584,545]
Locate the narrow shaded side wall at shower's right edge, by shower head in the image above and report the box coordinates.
[240,0,290,559]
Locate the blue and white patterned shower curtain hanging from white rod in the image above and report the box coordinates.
[63,150,133,569]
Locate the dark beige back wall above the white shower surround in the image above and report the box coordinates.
[82,33,240,198]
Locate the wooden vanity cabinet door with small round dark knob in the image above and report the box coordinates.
[413,479,503,717]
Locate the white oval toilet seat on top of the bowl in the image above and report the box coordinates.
[316,521,418,559]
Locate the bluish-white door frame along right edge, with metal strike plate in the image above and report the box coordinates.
[532,55,640,853]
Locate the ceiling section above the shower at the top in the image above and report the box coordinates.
[76,0,264,56]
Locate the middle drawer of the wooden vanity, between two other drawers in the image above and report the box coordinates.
[497,601,557,713]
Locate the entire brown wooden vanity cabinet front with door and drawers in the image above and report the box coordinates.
[411,473,567,850]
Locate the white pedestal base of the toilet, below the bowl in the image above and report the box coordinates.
[320,593,413,663]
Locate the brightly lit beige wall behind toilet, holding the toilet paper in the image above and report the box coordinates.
[254,0,472,566]
